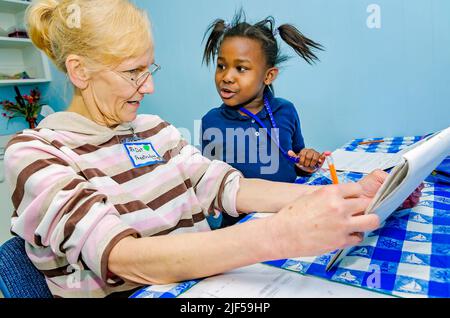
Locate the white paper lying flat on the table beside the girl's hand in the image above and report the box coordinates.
[333,149,402,173]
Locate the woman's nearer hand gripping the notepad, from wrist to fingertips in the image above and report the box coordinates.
[269,181,381,258]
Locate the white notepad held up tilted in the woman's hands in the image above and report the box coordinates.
[326,127,450,271]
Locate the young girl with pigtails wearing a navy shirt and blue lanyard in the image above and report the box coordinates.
[202,11,324,223]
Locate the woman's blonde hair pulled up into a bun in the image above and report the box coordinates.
[26,0,153,73]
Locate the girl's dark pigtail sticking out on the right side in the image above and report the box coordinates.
[278,24,323,64]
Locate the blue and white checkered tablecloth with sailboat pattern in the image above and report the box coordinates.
[132,137,450,298]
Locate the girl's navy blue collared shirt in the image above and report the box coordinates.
[201,90,305,182]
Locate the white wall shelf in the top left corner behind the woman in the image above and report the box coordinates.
[0,0,51,86]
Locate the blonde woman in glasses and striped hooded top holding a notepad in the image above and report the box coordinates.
[5,0,385,297]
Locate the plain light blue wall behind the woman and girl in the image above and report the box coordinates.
[0,0,450,150]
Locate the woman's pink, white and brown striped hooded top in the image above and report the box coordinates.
[5,112,242,297]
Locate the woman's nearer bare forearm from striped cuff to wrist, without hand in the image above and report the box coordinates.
[108,215,276,285]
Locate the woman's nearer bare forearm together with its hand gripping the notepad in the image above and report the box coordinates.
[108,179,384,284]
